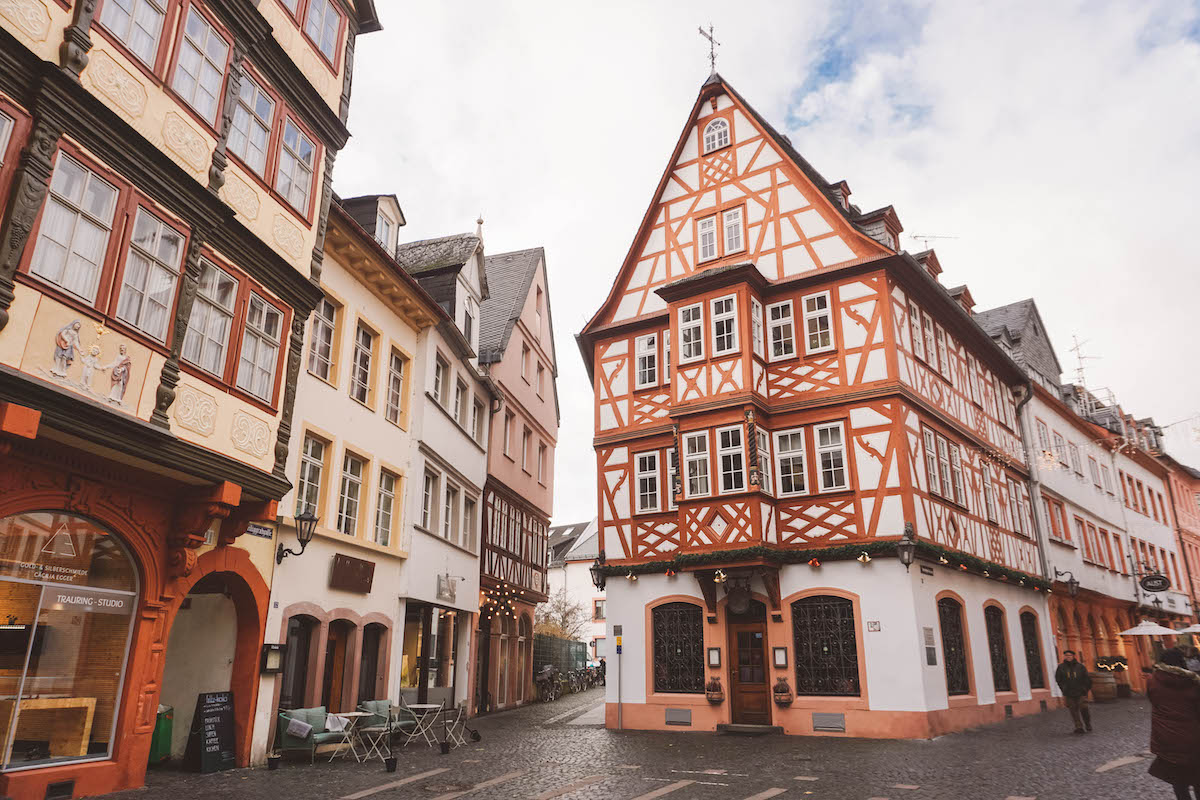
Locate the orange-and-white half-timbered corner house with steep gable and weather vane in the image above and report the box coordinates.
[580,73,1052,736]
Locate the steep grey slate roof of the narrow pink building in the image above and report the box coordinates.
[479,247,549,367]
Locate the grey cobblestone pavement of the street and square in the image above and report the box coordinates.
[109,688,1172,800]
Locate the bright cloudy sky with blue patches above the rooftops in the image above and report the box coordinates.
[334,0,1200,524]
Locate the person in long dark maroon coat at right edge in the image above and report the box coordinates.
[1146,649,1200,800]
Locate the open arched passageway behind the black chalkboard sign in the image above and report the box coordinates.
[160,572,238,759]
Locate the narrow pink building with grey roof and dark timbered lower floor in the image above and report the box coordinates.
[474,247,559,711]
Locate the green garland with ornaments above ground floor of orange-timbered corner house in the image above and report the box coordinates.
[600,540,1050,591]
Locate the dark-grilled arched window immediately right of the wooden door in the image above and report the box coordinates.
[792,595,862,697]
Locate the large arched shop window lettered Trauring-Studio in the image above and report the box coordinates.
[0,512,138,769]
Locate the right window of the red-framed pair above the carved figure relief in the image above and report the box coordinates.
[116,206,184,342]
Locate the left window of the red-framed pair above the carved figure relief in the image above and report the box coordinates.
[30,151,116,302]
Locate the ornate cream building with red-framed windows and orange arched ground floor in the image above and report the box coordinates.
[0,0,379,798]
